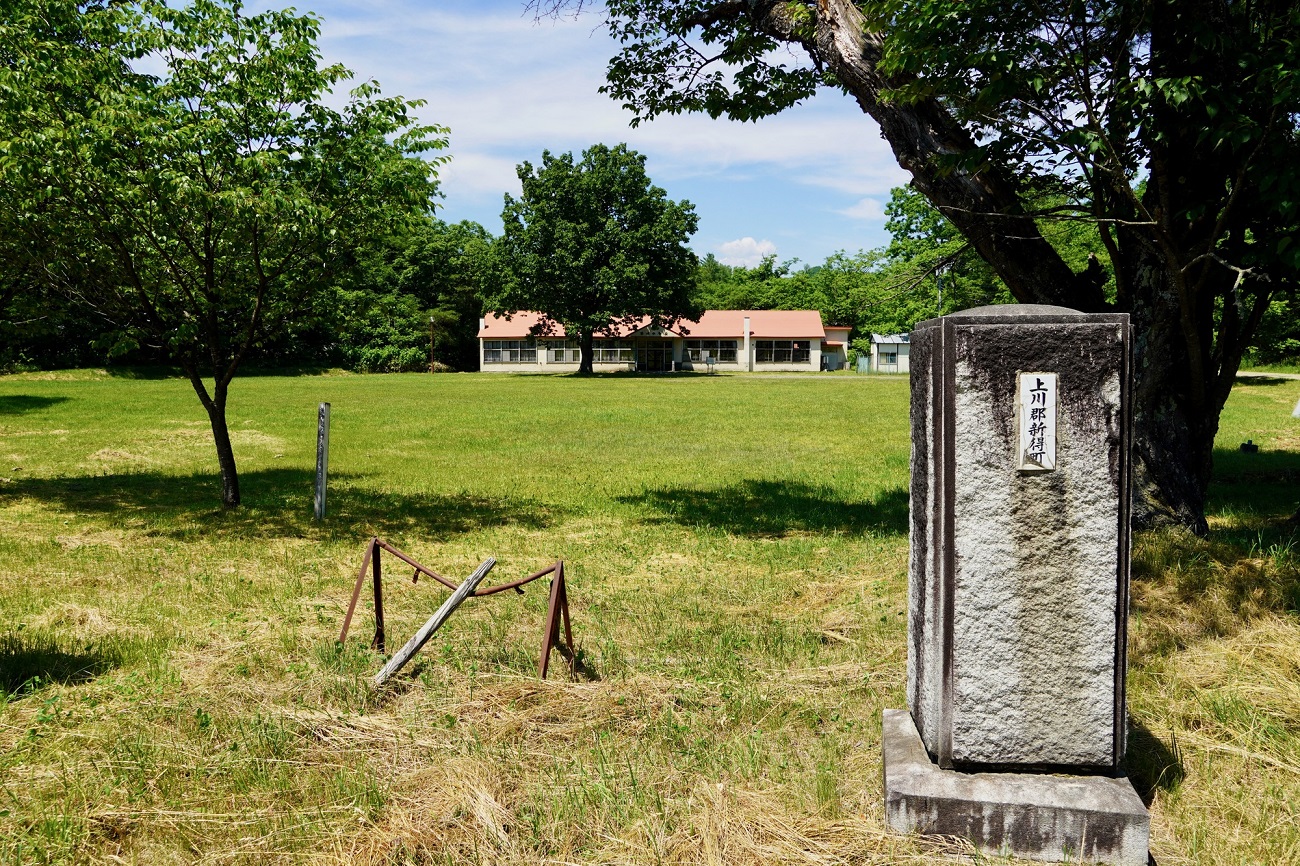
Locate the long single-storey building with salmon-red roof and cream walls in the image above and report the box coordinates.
[478,309,850,373]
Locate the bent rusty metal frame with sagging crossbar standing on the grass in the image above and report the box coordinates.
[338,537,576,680]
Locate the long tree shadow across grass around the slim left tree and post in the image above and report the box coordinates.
[0,468,554,541]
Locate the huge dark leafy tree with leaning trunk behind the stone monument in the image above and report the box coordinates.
[534,0,1300,532]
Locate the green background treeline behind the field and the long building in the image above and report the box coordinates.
[0,189,1300,372]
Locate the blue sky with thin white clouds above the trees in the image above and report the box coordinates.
[247,0,907,264]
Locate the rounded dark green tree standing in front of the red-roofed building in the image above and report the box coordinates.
[489,144,701,373]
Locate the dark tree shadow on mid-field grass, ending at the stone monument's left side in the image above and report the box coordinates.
[619,479,907,536]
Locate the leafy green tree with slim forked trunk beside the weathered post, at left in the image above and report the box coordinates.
[0,0,446,507]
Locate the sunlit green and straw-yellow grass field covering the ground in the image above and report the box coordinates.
[0,371,1300,866]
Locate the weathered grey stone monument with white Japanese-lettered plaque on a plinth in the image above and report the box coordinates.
[884,304,1149,866]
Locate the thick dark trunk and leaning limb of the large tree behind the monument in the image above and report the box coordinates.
[748,0,1240,533]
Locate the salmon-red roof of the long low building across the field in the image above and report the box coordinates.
[478,309,826,339]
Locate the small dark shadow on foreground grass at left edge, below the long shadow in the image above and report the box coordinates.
[0,632,126,697]
